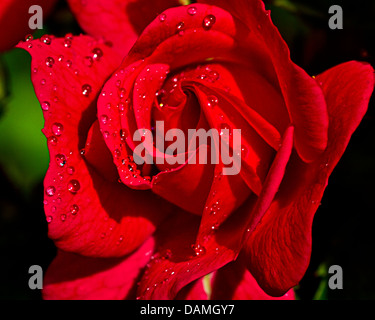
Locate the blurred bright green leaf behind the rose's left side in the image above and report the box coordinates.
[0,49,48,195]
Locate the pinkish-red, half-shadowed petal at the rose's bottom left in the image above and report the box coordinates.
[43,239,154,300]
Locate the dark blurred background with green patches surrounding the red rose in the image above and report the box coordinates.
[0,0,375,300]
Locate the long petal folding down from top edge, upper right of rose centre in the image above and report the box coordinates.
[198,0,328,162]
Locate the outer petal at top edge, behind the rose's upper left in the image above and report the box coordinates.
[68,0,179,54]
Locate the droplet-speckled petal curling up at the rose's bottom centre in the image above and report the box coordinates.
[138,197,255,300]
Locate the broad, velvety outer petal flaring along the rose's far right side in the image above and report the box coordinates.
[245,62,374,296]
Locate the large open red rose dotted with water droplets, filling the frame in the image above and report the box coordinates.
[19,0,374,299]
